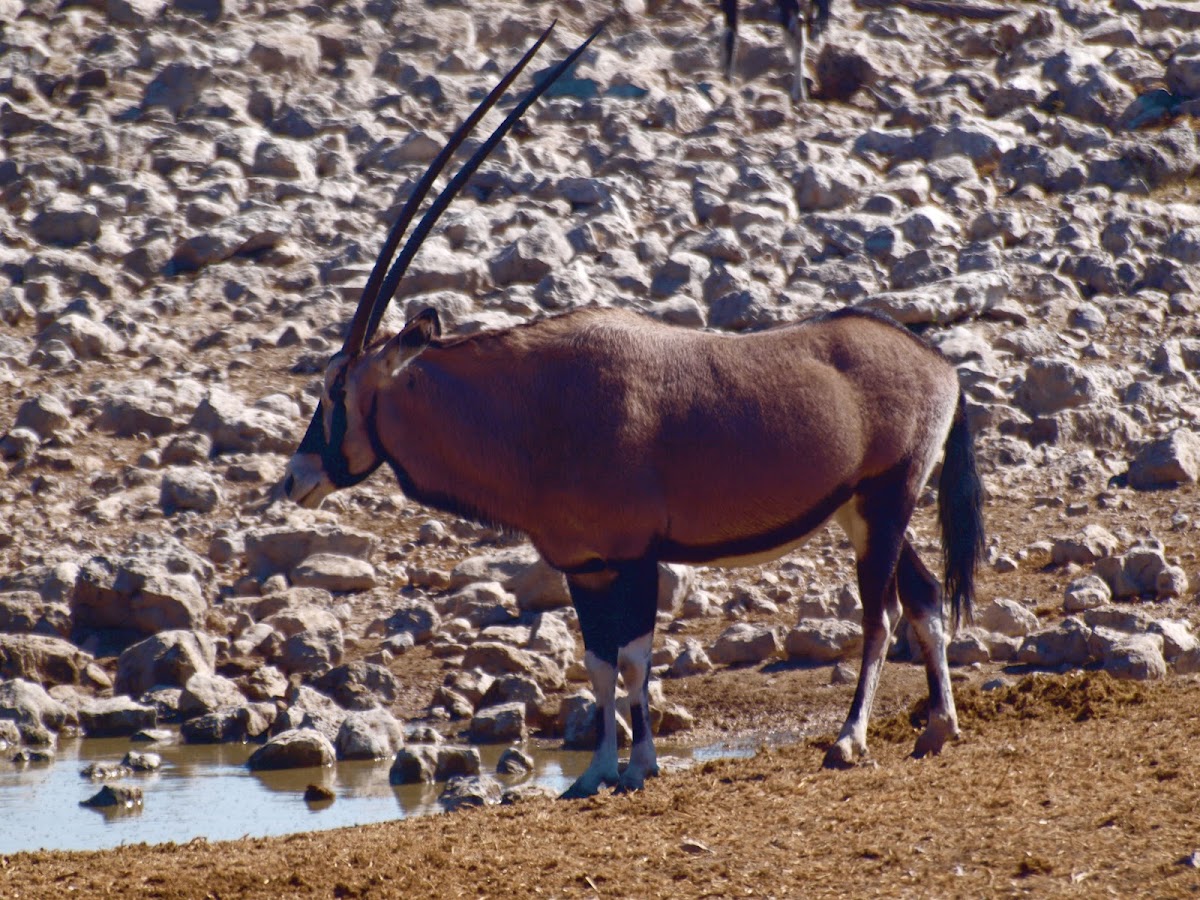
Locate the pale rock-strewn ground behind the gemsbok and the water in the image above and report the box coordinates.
[0,0,1200,888]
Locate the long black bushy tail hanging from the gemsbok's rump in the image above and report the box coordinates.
[937,391,985,629]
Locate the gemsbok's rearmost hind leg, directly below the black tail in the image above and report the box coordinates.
[896,540,959,756]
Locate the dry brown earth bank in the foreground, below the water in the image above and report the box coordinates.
[7,667,1200,898]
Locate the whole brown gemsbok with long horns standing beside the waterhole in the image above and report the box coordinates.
[282,19,983,797]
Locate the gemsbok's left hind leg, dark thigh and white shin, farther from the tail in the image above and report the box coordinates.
[824,494,912,768]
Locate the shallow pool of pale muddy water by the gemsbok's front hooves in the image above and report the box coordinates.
[0,738,752,853]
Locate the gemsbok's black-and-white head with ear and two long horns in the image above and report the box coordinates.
[280,20,607,506]
